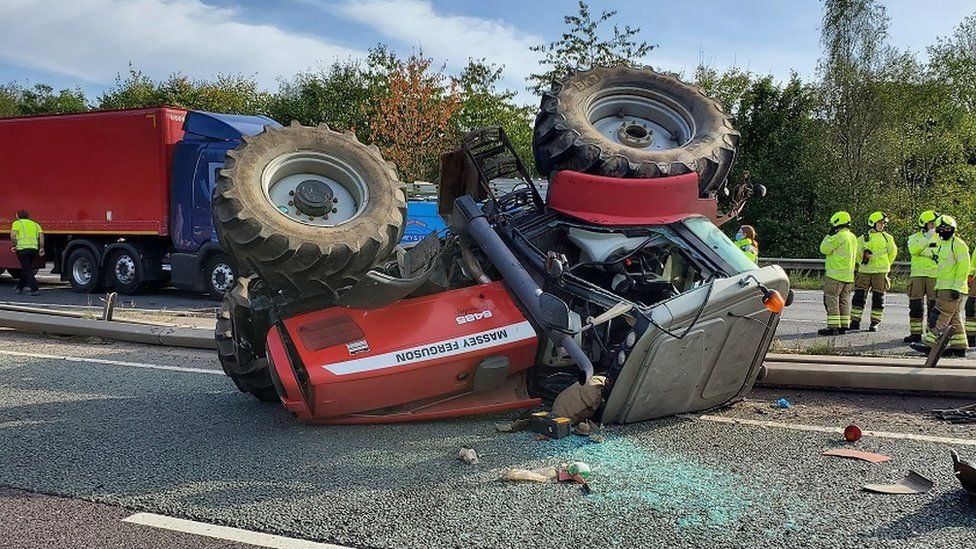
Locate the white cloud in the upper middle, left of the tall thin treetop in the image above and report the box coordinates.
[332,0,545,99]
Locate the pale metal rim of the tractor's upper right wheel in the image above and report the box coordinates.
[587,88,695,151]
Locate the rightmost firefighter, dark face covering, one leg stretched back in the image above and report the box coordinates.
[911,215,970,357]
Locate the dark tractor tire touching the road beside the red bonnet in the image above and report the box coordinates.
[214,283,278,402]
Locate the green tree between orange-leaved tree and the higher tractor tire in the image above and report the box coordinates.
[451,59,535,169]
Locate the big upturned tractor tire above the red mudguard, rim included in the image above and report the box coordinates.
[532,65,739,197]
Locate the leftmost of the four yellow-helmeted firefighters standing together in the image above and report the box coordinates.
[817,212,857,335]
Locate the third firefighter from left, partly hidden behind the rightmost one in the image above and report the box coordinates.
[904,210,940,343]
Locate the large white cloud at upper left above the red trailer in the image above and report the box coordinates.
[0,0,364,88]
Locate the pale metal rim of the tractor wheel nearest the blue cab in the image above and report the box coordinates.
[261,151,369,227]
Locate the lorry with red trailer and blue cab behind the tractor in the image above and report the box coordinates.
[0,107,278,297]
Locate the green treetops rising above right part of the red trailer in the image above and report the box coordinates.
[99,66,270,114]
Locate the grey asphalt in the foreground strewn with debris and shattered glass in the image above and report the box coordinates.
[0,332,976,548]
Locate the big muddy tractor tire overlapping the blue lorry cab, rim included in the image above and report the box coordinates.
[213,122,407,298]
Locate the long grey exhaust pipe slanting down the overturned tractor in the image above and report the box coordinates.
[453,196,593,381]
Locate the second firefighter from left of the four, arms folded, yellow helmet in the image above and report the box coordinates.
[850,212,898,332]
